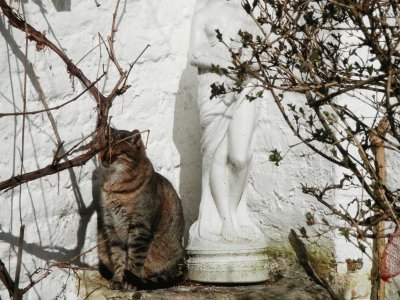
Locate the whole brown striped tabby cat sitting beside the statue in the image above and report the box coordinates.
[97,129,184,289]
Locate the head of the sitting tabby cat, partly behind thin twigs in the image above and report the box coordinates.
[99,128,146,168]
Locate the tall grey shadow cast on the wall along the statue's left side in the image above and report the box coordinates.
[173,65,201,241]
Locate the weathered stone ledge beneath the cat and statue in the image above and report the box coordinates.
[77,267,330,300]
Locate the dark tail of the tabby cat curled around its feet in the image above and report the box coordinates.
[125,270,184,289]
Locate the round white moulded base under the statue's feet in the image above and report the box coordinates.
[186,248,269,283]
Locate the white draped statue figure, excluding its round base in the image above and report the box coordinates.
[189,0,264,242]
